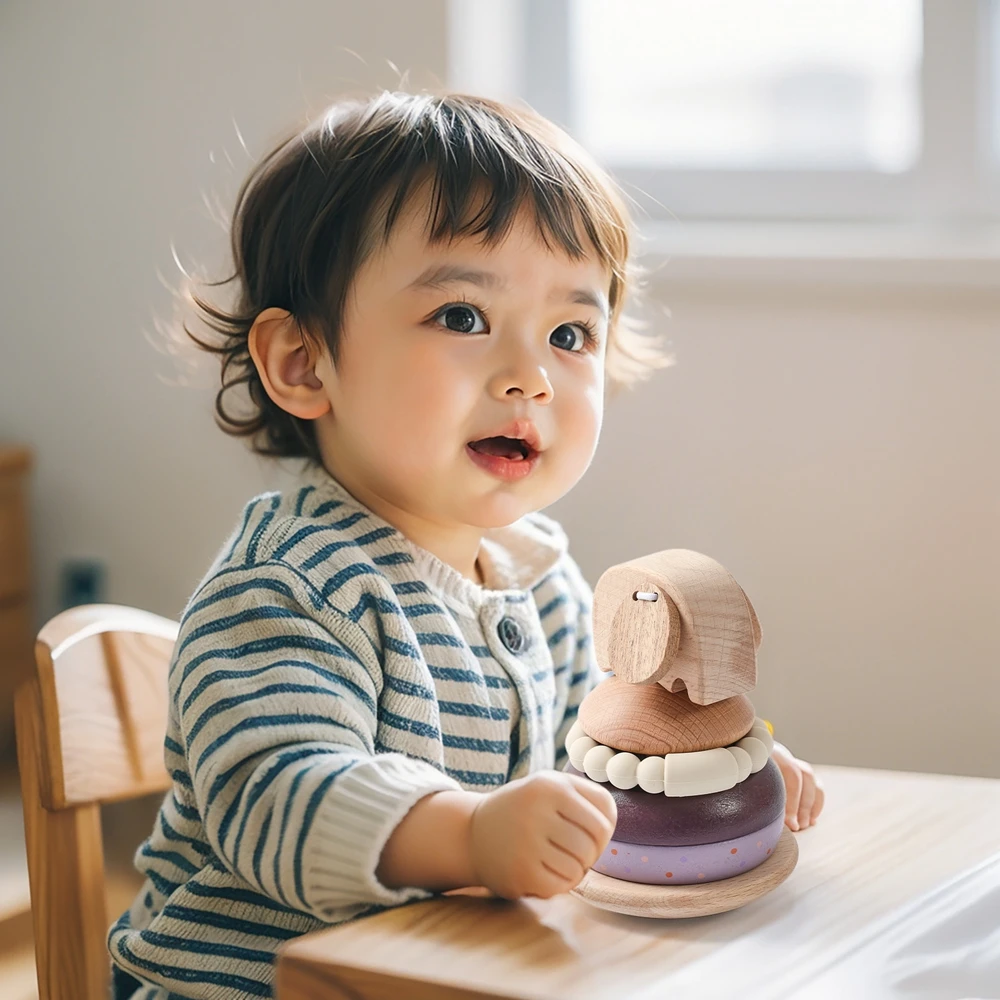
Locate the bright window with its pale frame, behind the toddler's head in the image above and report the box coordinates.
[451,0,1000,225]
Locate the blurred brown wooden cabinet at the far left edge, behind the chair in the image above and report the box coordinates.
[0,445,35,758]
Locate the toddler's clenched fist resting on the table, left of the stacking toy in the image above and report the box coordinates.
[470,771,618,899]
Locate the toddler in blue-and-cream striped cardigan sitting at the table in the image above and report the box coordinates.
[109,93,822,1000]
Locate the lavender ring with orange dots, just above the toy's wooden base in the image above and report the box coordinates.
[594,815,785,885]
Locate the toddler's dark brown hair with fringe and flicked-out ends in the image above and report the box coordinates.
[184,92,670,460]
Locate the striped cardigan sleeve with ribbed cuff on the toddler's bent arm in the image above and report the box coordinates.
[167,562,461,919]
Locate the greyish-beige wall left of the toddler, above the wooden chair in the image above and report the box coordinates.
[0,0,446,616]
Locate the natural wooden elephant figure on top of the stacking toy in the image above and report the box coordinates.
[594,549,761,705]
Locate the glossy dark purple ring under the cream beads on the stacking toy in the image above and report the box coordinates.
[565,758,785,847]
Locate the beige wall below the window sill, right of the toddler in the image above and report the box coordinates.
[550,282,1000,777]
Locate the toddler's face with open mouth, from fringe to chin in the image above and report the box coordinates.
[316,193,609,529]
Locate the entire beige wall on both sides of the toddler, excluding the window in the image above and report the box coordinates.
[0,0,1000,776]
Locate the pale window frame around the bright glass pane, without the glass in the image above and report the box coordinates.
[449,0,1000,226]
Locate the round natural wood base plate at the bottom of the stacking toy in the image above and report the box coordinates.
[572,827,799,919]
